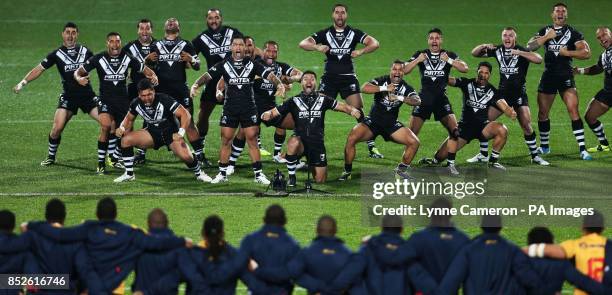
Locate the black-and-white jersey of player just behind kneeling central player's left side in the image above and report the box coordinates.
[253,60,293,110]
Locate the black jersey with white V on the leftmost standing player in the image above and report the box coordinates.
[40,44,94,98]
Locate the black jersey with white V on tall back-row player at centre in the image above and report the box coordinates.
[312,26,368,75]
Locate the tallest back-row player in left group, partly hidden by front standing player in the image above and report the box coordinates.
[191,8,242,166]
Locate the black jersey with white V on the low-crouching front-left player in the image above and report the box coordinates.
[130,93,180,129]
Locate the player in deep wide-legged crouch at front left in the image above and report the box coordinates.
[114,79,211,183]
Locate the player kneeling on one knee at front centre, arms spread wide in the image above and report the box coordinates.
[261,71,363,186]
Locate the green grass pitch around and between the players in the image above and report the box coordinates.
[0,0,612,294]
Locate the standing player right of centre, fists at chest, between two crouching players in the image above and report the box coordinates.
[404,28,468,166]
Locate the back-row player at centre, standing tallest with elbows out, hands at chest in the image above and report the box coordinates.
[299,4,383,159]
